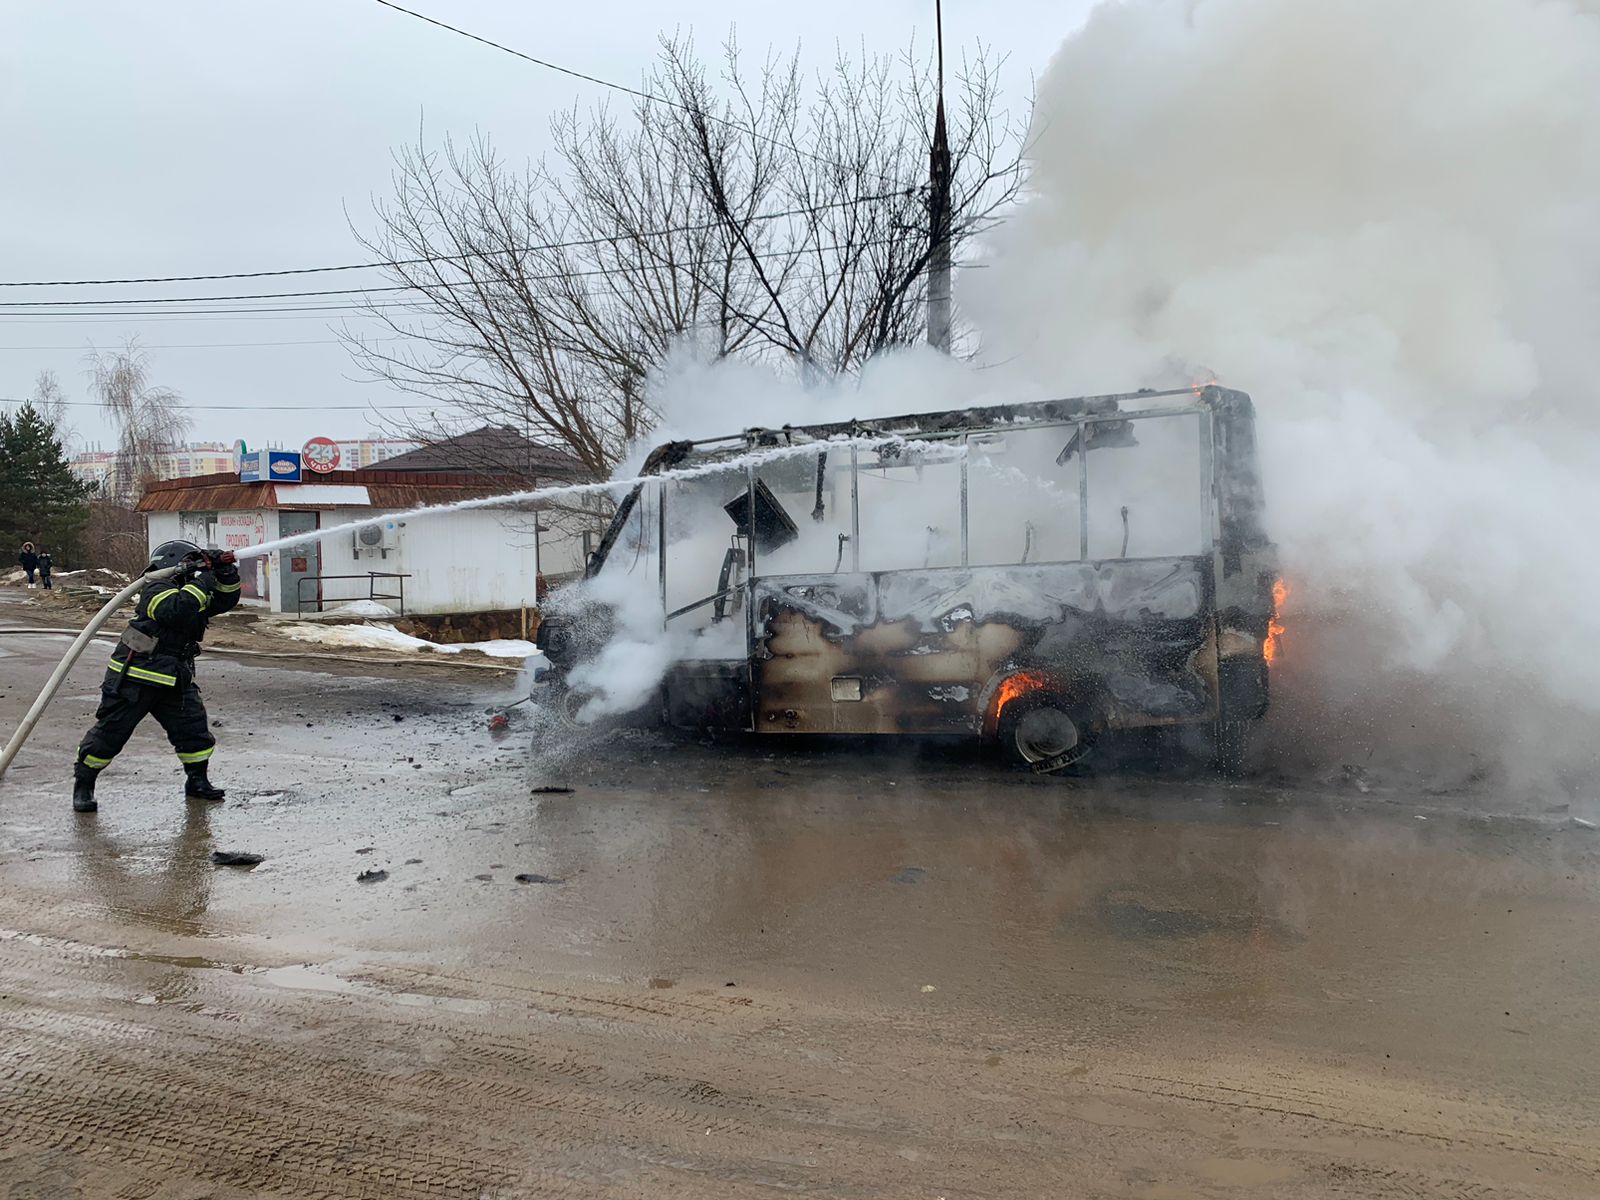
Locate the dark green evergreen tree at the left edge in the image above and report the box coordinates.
[0,403,90,570]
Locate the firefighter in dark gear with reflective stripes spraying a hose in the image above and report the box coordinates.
[72,541,238,813]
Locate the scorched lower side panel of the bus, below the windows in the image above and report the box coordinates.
[754,558,1216,734]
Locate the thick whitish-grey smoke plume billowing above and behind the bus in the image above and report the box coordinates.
[965,0,1600,782]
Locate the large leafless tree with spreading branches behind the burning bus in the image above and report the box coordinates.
[344,29,1026,477]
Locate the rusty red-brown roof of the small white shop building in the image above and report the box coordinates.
[138,469,522,512]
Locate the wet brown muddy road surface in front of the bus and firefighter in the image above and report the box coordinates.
[0,594,1600,1200]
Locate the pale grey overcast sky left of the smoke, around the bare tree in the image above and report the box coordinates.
[0,0,1090,446]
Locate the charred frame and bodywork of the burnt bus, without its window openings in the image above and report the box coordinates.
[556,386,1277,770]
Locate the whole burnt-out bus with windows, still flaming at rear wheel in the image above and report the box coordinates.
[541,387,1277,770]
